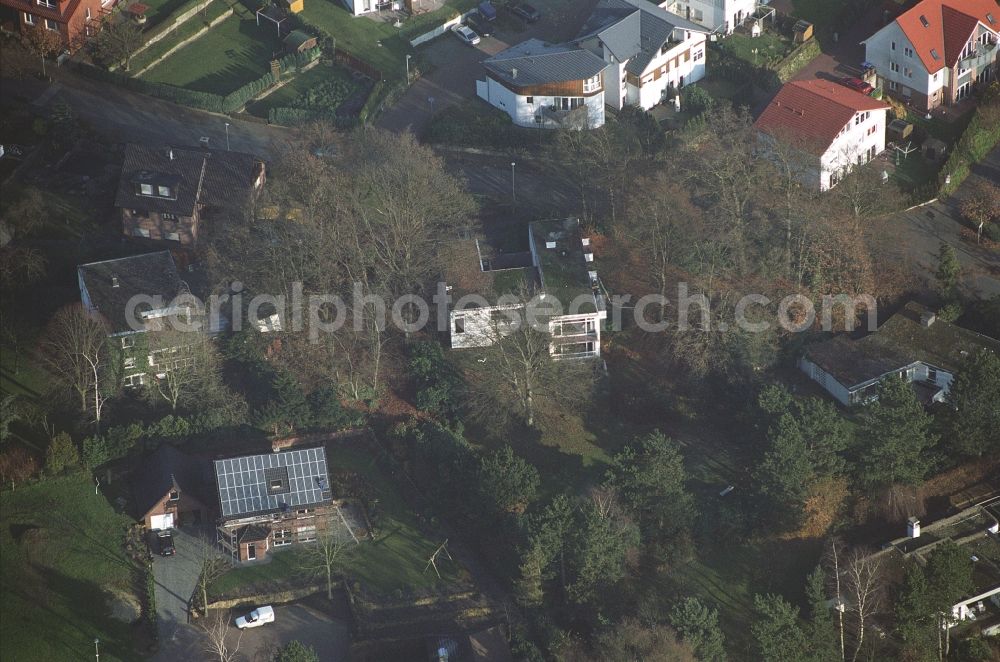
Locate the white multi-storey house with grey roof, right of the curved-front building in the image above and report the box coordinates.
[576,0,710,110]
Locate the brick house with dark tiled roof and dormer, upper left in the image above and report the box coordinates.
[115,143,265,247]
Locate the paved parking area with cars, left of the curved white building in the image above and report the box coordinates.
[378,0,597,135]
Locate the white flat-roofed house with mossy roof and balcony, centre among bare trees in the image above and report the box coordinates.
[445,218,607,359]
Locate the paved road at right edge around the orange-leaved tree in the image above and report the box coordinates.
[881,147,1000,297]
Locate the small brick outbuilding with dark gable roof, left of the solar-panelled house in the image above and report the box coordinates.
[129,445,213,531]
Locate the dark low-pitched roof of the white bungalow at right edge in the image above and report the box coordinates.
[806,301,1000,388]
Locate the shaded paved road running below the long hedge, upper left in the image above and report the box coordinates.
[0,67,288,159]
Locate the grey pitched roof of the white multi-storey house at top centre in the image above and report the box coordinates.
[577,0,708,76]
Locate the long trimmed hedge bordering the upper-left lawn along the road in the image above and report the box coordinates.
[71,46,320,113]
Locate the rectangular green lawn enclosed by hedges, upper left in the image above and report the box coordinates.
[142,16,281,96]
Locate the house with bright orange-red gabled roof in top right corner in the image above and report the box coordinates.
[862,0,1000,110]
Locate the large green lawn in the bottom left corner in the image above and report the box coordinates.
[0,472,141,662]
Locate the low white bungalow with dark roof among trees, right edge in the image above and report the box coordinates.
[799,302,1000,405]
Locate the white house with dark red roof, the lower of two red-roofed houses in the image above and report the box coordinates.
[755,80,889,191]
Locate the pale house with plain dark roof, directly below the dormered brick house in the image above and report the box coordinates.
[77,251,203,386]
